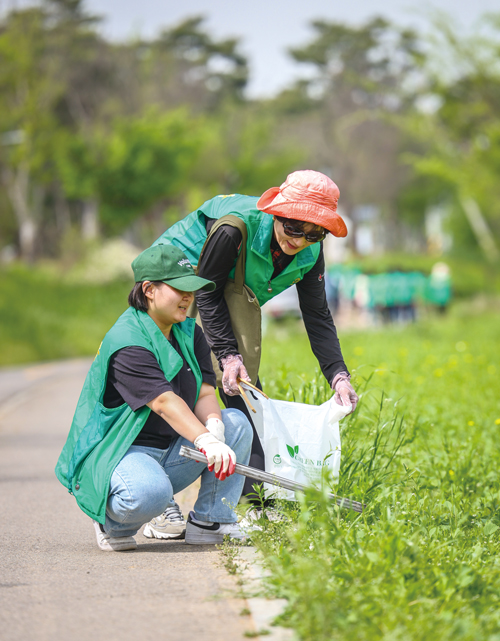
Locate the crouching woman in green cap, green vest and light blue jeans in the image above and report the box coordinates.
[56,244,252,551]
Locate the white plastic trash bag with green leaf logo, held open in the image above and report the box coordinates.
[241,381,351,501]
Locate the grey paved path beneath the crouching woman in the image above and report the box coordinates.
[0,359,254,641]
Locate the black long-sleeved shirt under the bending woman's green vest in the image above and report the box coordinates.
[195,219,348,383]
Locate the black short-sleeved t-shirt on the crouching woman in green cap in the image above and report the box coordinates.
[103,325,216,450]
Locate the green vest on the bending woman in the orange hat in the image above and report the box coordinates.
[154,194,320,305]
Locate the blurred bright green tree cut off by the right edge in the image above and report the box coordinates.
[407,15,500,262]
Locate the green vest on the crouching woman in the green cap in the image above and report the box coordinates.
[55,307,202,523]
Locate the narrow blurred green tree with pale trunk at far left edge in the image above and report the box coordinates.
[0,8,62,261]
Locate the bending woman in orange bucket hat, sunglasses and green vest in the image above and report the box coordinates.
[146,170,358,520]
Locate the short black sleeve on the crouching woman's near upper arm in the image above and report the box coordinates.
[103,346,172,412]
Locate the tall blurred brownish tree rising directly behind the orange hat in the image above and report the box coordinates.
[276,18,419,246]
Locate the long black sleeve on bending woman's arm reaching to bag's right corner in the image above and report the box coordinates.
[297,244,348,384]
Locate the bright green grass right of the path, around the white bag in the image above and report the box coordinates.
[253,306,500,641]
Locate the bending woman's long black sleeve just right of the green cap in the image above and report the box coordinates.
[196,225,242,360]
